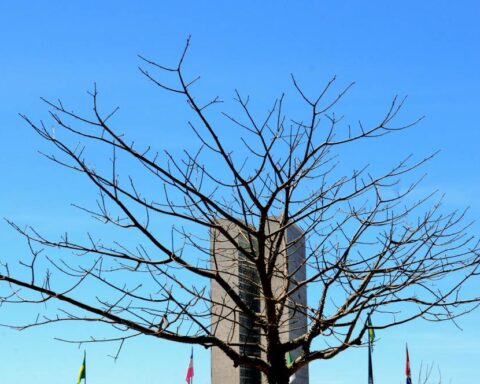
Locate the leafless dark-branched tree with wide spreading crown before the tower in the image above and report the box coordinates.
[0,36,480,384]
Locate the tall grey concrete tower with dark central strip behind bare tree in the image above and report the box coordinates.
[210,219,308,384]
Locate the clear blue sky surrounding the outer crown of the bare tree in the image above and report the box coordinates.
[0,0,480,384]
